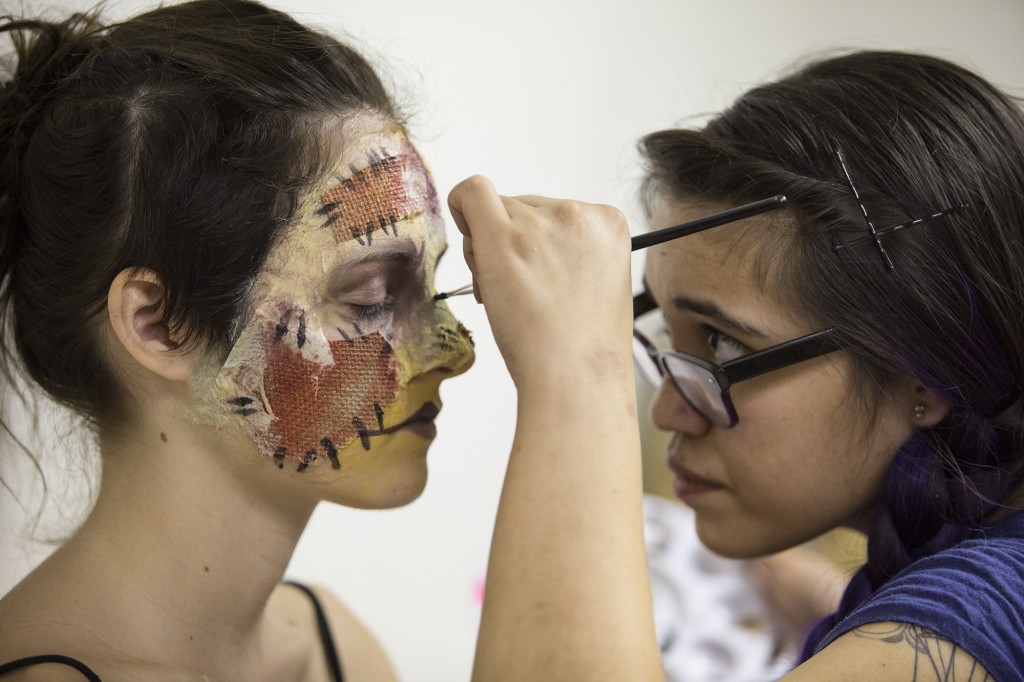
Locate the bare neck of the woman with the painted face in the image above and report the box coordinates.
[62,403,315,669]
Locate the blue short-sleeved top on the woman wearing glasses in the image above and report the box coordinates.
[817,511,1024,680]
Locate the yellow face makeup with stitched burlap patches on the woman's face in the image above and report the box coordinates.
[217,122,473,471]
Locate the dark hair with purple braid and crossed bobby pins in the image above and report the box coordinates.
[641,51,1024,650]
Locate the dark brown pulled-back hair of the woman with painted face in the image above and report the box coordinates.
[0,0,395,424]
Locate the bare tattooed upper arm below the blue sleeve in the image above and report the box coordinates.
[783,623,994,682]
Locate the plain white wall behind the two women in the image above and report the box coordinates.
[0,0,1024,682]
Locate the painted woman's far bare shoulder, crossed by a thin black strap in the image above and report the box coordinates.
[274,585,398,682]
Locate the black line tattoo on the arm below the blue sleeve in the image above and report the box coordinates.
[852,623,995,682]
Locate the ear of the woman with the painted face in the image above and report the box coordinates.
[106,268,190,381]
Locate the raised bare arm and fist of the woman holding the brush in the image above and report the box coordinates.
[449,177,664,682]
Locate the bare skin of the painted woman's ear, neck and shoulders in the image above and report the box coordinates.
[0,280,403,682]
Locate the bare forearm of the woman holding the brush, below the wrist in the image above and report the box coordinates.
[473,354,663,682]
